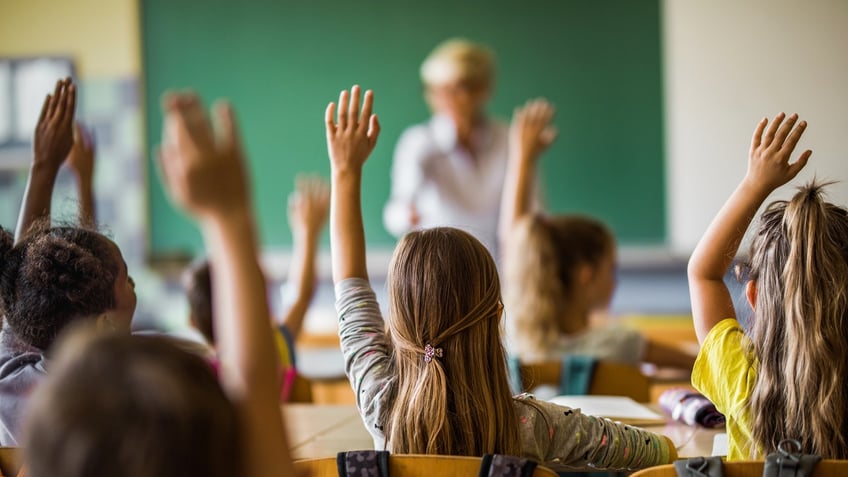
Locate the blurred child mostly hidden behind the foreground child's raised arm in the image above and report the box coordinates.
[183,177,330,401]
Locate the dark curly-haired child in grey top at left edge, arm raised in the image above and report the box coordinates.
[0,79,136,446]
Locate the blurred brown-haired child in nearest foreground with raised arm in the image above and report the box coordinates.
[24,95,295,477]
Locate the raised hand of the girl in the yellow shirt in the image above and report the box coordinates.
[745,113,813,192]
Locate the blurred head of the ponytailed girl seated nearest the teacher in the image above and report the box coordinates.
[504,215,616,359]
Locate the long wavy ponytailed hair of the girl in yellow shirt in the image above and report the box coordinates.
[748,183,848,459]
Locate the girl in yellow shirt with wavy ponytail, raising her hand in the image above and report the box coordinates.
[689,113,848,459]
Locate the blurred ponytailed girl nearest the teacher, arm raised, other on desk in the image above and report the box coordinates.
[501,100,695,370]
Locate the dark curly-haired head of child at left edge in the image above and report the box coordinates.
[0,225,136,350]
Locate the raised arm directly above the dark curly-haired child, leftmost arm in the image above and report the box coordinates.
[15,78,77,242]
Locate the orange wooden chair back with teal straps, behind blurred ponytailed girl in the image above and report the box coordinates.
[519,361,651,402]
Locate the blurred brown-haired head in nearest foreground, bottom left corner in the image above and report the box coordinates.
[23,330,242,477]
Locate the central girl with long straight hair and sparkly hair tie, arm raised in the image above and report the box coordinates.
[325,86,676,469]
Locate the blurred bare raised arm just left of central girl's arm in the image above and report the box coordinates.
[280,176,330,338]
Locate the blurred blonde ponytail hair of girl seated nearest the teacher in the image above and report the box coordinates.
[504,215,615,362]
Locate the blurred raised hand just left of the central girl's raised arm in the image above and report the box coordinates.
[288,176,330,240]
